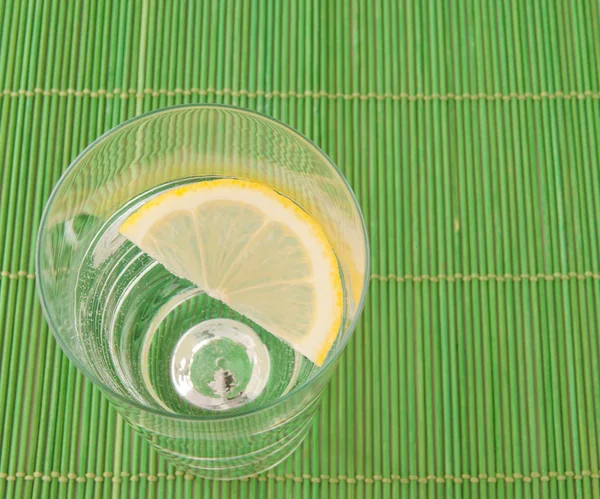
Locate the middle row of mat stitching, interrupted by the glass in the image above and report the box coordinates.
[0,270,600,282]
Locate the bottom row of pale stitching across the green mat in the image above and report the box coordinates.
[0,470,600,484]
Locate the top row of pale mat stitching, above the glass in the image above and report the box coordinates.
[0,88,600,101]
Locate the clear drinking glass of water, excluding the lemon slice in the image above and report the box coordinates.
[36,105,369,479]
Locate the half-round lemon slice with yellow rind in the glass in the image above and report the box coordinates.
[119,179,343,365]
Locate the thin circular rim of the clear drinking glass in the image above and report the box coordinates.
[35,104,371,422]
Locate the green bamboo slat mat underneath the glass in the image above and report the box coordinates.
[0,0,600,499]
